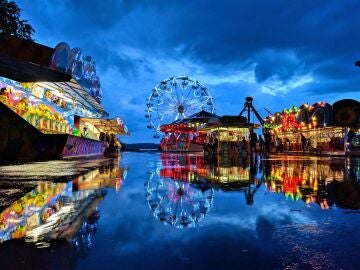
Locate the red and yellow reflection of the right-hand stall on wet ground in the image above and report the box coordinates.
[264,159,360,209]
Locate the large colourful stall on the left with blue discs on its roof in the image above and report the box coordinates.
[0,35,127,162]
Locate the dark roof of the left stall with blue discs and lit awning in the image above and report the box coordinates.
[0,34,108,117]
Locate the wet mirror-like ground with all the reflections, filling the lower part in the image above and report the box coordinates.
[0,152,360,269]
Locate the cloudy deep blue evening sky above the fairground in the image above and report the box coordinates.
[16,0,360,143]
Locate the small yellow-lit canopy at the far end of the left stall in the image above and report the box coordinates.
[81,117,128,135]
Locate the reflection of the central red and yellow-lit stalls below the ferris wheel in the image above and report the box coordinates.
[157,153,262,204]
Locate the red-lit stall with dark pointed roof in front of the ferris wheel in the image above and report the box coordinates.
[160,110,219,152]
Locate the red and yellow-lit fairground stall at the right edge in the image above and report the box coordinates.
[264,99,360,155]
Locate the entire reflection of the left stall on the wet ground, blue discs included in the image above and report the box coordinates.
[0,159,126,246]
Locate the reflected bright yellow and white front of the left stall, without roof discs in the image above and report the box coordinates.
[0,182,103,242]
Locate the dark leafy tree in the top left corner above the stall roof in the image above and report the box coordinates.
[0,0,35,40]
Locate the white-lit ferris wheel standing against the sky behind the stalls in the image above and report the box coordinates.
[145,76,215,138]
